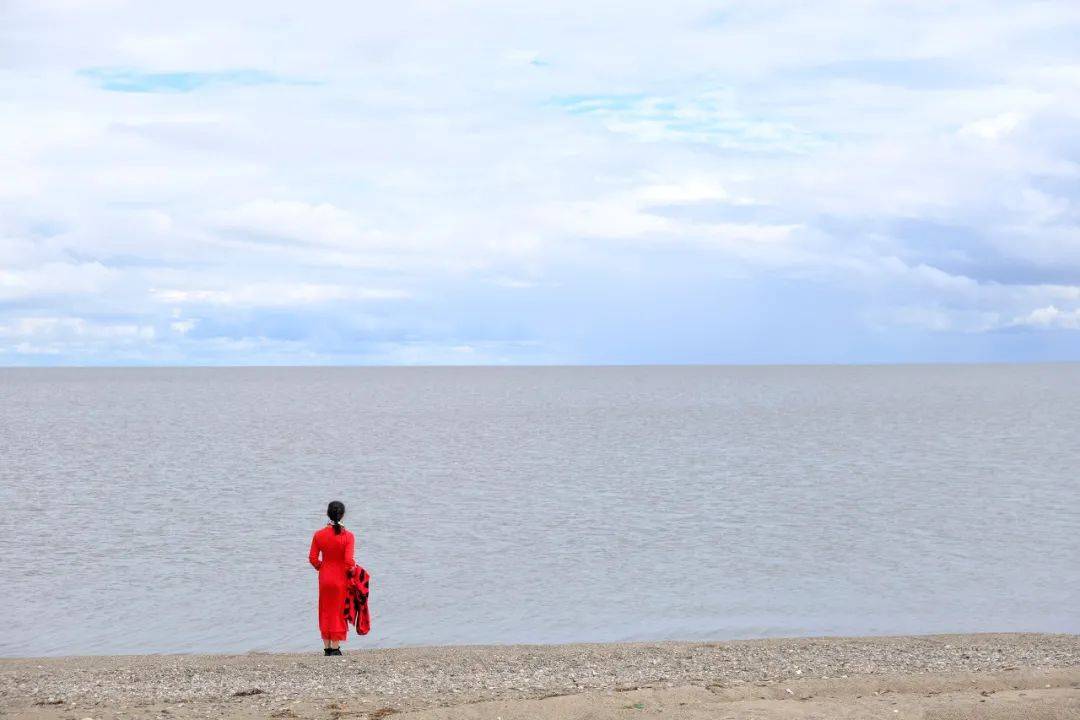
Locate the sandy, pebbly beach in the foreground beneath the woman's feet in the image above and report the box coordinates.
[0,634,1080,720]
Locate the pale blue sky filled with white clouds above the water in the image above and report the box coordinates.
[0,0,1080,366]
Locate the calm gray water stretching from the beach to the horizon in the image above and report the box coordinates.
[0,365,1080,655]
